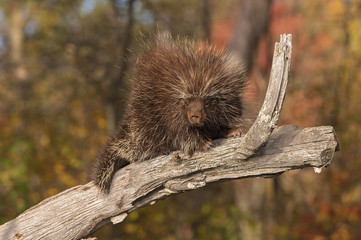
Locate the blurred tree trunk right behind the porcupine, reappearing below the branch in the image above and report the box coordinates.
[229,0,275,240]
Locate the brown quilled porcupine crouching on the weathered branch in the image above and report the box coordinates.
[94,36,247,192]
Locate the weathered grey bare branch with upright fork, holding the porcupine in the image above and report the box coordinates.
[0,36,338,239]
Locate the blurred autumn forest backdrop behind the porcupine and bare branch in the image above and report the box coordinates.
[0,0,361,240]
